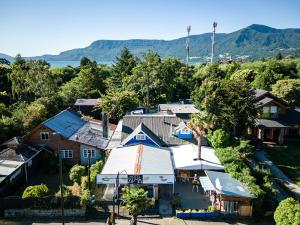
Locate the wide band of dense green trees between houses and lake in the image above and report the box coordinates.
[0,48,300,142]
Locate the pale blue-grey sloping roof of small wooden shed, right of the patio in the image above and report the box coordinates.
[205,170,255,198]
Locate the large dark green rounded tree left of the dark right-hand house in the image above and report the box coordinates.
[194,80,257,136]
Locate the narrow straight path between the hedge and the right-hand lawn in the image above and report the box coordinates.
[255,151,300,198]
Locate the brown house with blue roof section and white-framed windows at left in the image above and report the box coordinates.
[25,108,115,164]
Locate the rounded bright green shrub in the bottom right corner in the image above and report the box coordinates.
[274,198,300,225]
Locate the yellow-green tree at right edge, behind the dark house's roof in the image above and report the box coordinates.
[272,79,300,106]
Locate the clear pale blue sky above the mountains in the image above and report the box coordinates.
[0,0,300,56]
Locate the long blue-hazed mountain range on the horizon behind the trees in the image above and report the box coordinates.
[0,24,300,62]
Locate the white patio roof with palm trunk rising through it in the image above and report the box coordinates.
[169,144,224,170]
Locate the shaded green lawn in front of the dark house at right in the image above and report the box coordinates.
[265,141,300,186]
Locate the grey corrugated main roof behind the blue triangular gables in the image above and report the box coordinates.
[121,114,196,145]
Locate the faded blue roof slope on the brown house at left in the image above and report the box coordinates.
[42,109,86,138]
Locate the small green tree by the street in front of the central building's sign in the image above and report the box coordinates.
[122,187,152,225]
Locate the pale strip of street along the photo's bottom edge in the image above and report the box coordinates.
[0,217,275,225]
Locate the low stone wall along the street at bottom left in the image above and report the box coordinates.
[4,207,86,218]
